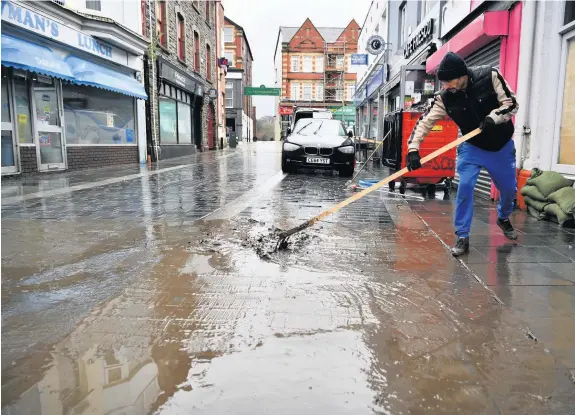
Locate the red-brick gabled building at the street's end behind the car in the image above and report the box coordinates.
[274,19,360,140]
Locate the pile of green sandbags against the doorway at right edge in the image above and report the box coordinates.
[521,169,575,227]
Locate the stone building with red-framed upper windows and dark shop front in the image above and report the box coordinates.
[142,0,219,160]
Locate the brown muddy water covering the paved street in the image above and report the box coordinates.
[2,145,575,415]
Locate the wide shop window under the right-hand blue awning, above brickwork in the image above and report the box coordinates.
[62,84,136,144]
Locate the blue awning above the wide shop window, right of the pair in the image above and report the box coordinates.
[66,56,148,99]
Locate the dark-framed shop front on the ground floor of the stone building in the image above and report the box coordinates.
[158,60,206,159]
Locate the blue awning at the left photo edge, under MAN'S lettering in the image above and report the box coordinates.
[2,34,74,81]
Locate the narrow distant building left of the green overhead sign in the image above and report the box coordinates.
[224,16,255,141]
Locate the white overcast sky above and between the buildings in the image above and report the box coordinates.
[222,0,371,118]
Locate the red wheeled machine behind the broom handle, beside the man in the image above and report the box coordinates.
[382,110,458,194]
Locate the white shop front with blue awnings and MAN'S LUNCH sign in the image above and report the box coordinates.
[1,2,147,175]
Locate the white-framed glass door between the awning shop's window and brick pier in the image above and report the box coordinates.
[32,75,66,171]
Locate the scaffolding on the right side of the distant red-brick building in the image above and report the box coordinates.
[323,38,347,107]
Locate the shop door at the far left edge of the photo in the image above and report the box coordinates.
[1,67,18,174]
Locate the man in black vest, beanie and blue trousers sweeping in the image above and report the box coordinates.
[407,52,518,256]
